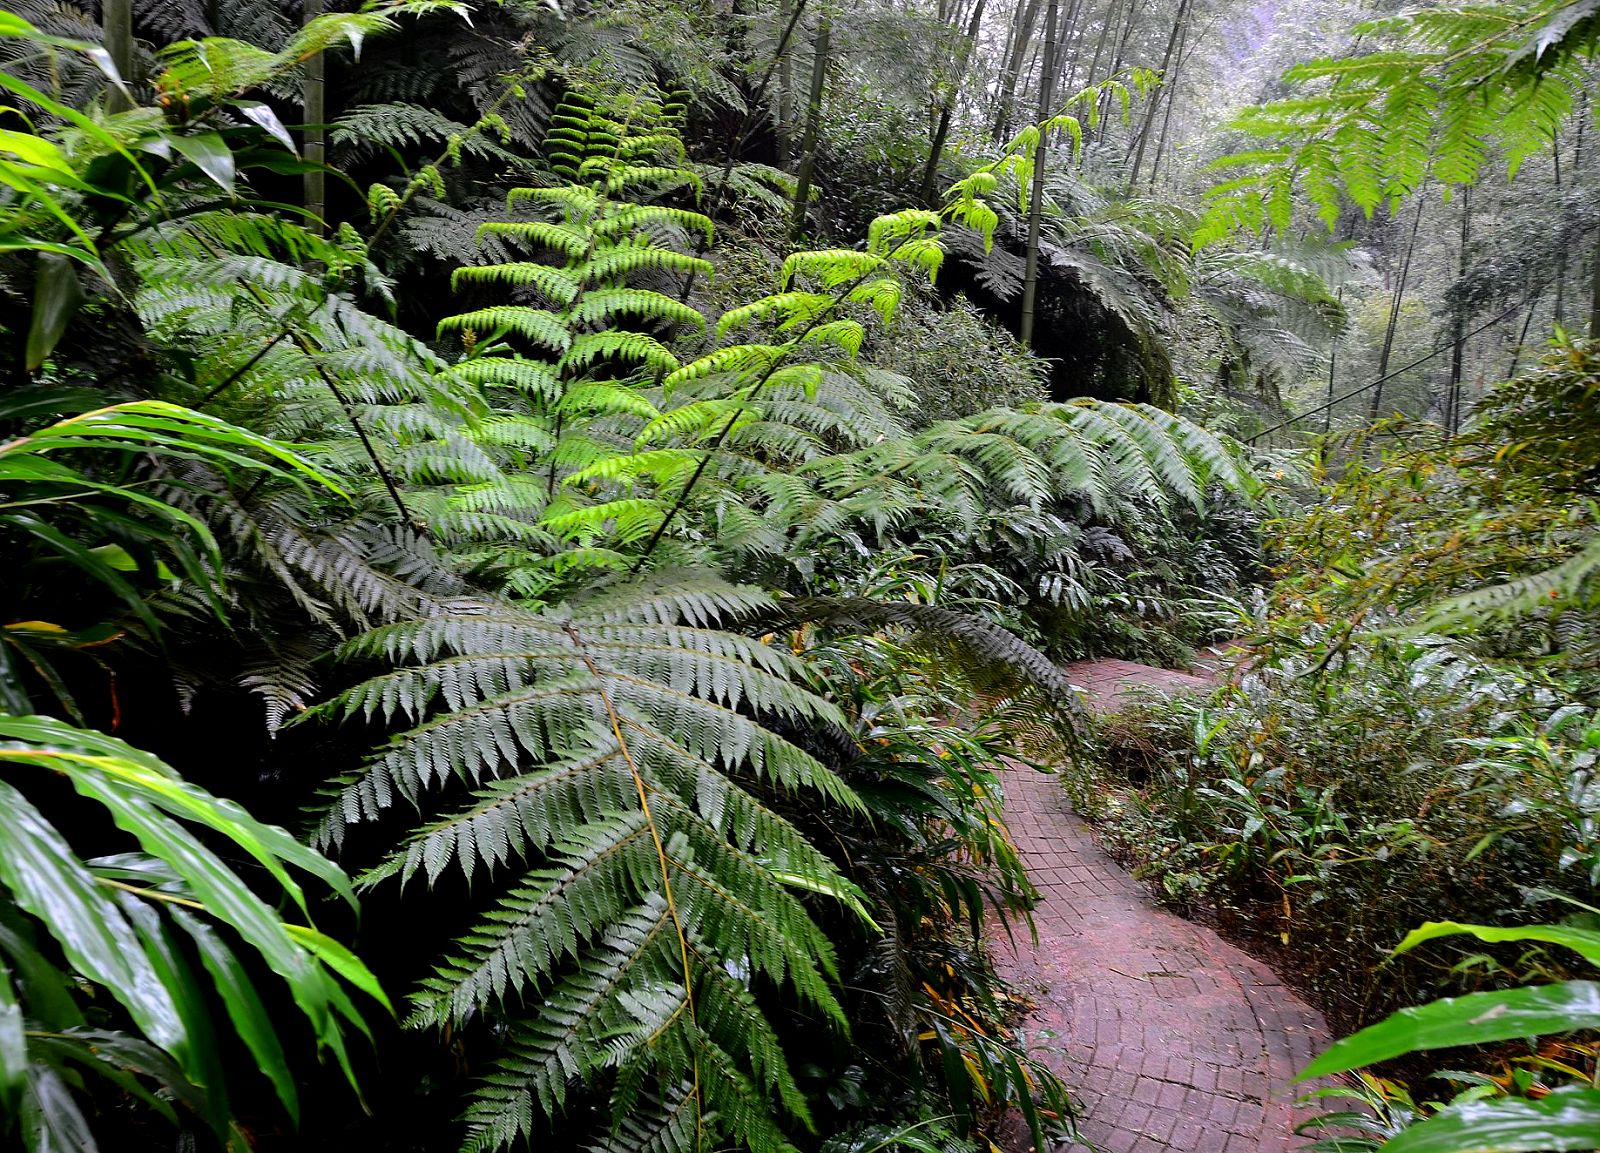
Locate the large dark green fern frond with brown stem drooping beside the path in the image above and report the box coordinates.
[320,579,859,1150]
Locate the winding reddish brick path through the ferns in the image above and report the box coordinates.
[994,662,1326,1153]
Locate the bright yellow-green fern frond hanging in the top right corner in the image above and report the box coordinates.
[1197,0,1600,243]
